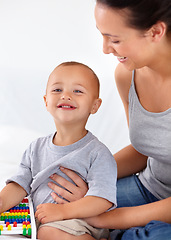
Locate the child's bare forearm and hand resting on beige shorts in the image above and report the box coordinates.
[35,196,112,223]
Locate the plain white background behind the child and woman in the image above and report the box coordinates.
[0,0,129,191]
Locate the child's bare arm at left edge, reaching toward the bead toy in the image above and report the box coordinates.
[0,182,27,213]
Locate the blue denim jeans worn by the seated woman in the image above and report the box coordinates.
[110,175,171,240]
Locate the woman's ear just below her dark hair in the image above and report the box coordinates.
[149,22,167,42]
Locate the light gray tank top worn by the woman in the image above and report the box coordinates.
[129,71,171,199]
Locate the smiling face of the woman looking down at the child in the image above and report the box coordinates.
[95,3,152,70]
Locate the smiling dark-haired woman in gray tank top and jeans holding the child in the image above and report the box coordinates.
[47,0,171,240]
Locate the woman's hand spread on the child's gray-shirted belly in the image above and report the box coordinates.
[48,167,88,204]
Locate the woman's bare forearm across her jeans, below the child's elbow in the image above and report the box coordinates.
[86,197,171,229]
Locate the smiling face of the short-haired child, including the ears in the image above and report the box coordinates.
[44,65,101,126]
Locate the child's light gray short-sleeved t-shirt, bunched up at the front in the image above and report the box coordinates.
[7,132,117,212]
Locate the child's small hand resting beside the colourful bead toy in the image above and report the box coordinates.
[35,203,64,223]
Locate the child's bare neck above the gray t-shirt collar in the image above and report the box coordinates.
[53,127,87,146]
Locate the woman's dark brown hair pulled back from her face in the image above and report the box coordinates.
[96,0,171,33]
